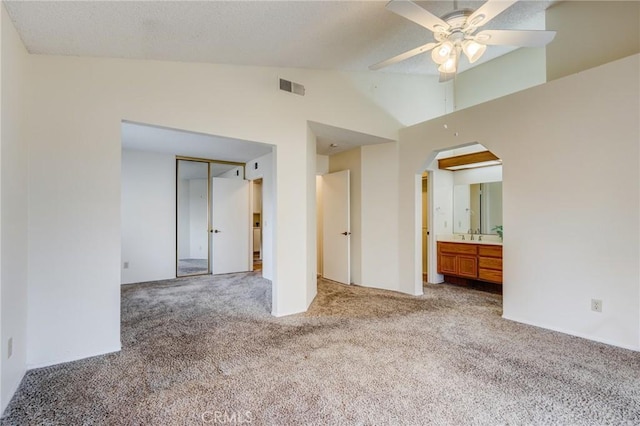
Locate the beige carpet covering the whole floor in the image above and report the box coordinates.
[0,274,640,425]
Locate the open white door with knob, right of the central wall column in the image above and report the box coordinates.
[322,170,351,284]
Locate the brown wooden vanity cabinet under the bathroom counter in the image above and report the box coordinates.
[438,242,502,284]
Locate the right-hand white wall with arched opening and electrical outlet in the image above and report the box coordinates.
[399,55,640,349]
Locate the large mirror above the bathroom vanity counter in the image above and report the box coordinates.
[453,182,502,234]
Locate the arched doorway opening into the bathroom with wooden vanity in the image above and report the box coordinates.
[416,143,503,293]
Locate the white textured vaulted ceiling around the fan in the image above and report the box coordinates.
[4,1,551,74]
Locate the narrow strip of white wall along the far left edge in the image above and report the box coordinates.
[0,1,28,413]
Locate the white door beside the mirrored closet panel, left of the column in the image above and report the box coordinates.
[211,177,251,274]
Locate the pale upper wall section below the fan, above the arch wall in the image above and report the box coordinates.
[454,47,547,109]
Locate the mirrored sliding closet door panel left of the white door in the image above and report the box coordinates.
[176,160,209,277]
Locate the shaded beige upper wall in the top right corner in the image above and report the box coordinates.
[546,1,640,81]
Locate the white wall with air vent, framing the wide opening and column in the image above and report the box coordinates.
[22,50,420,366]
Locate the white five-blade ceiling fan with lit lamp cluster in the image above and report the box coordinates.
[369,0,556,82]
